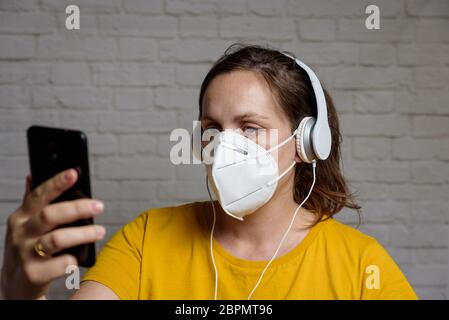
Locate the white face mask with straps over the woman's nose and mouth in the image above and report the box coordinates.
[203,131,296,220]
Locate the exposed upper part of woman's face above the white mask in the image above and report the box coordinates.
[201,70,300,185]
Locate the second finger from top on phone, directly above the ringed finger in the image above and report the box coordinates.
[25,199,104,234]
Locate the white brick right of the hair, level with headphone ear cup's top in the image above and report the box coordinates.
[340,114,410,137]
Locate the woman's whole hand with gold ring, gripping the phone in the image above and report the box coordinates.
[0,169,106,299]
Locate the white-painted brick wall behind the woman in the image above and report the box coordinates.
[0,0,449,299]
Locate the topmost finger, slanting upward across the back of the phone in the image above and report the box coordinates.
[23,169,78,213]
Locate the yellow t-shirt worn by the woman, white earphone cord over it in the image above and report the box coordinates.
[83,202,417,300]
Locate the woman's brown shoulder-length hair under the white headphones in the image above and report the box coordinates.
[199,44,361,223]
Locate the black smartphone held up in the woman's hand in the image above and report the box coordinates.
[27,126,95,267]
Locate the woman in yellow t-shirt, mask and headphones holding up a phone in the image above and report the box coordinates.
[1,46,417,299]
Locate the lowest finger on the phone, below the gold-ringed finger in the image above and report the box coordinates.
[25,254,78,285]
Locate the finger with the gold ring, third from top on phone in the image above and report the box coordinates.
[40,225,106,255]
